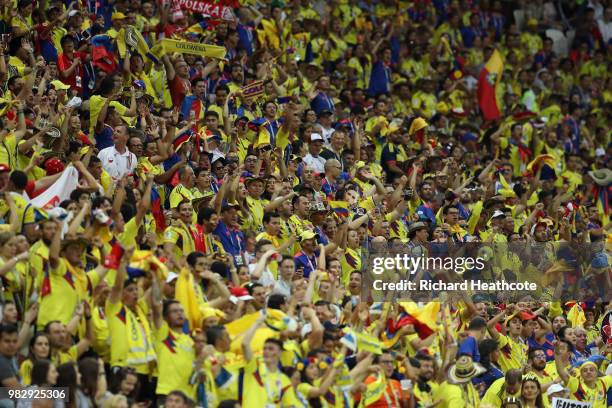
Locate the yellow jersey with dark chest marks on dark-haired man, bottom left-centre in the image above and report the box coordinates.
[153,322,195,398]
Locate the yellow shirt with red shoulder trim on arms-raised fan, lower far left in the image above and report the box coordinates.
[37,258,100,330]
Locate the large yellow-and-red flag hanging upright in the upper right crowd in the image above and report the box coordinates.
[477,49,504,121]
